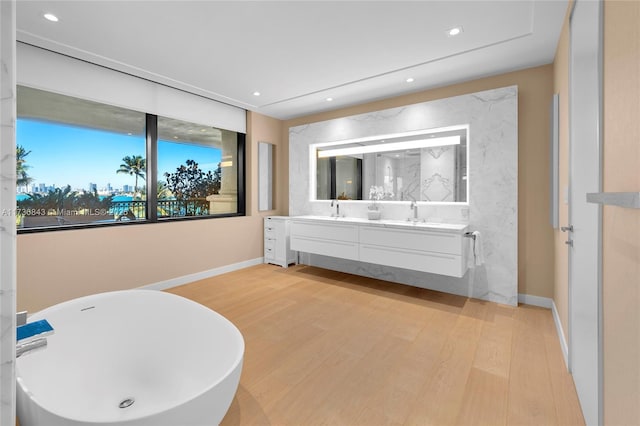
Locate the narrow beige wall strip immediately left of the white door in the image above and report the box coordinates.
[553,2,573,339]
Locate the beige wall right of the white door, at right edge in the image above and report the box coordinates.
[602,0,640,425]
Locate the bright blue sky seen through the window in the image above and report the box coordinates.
[16,119,221,193]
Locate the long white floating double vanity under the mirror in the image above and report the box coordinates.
[291,216,469,278]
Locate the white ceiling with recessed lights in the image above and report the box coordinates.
[17,0,567,119]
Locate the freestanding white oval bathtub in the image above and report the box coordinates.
[16,290,244,426]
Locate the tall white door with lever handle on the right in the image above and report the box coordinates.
[565,0,602,425]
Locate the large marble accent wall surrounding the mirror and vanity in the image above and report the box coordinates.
[289,86,518,305]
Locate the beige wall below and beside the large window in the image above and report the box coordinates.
[17,113,286,312]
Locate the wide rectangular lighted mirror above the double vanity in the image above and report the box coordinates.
[311,125,469,203]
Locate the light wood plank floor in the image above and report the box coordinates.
[169,265,584,425]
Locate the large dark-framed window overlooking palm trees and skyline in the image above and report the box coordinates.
[16,86,244,232]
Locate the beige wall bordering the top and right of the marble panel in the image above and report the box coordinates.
[284,65,554,298]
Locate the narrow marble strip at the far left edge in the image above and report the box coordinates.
[0,0,16,425]
